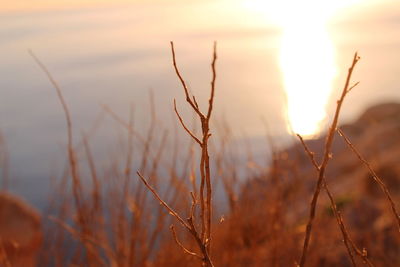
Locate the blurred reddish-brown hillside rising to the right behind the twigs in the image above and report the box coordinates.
[157,103,400,266]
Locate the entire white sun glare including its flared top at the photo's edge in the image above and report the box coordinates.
[246,0,367,137]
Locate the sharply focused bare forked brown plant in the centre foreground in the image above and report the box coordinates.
[137,42,217,266]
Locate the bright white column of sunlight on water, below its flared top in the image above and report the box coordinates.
[280,18,336,137]
